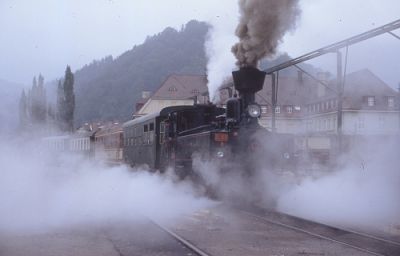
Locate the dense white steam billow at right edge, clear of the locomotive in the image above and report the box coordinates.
[277,141,400,231]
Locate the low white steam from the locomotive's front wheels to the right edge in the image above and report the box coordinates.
[193,134,400,234]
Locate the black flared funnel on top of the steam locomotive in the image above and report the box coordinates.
[232,67,266,109]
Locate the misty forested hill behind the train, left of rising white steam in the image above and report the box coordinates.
[75,21,208,125]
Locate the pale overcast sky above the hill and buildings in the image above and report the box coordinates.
[0,0,400,87]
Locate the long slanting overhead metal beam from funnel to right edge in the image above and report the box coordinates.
[264,19,400,74]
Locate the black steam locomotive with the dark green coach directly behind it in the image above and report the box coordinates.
[123,67,290,177]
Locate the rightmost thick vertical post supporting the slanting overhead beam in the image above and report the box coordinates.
[336,51,343,154]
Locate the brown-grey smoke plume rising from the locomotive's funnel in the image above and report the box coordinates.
[232,0,300,67]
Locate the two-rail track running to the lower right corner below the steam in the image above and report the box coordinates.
[240,207,400,256]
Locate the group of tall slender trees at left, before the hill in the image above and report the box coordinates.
[19,66,75,132]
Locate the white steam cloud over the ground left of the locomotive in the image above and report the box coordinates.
[0,138,212,232]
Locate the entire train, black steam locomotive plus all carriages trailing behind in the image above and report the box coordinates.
[43,67,294,178]
